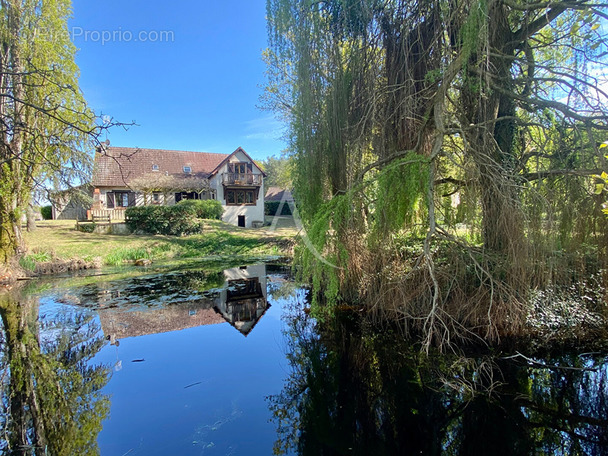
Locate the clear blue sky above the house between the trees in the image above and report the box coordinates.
[69,0,286,159]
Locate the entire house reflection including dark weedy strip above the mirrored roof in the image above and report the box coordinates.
[84,264,270,344]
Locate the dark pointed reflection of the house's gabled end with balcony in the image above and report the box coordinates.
[216,264,270,336]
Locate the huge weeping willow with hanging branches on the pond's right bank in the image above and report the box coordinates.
[267,0,608,346]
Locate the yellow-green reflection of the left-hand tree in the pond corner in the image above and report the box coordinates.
[0,294,110,456]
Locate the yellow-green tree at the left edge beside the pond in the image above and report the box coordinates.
[0,0,96,265]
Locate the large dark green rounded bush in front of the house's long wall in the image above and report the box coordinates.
[125,205,203,236]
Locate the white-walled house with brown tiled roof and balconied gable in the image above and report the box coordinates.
[91,142,265,227]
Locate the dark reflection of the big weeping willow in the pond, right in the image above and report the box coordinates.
[269,304,608,455]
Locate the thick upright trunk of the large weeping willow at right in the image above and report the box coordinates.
[462,2,526,263]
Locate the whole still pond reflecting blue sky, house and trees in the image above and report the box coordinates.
[0,263,608,456]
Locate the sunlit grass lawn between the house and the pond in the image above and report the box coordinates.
[22,217,296,269]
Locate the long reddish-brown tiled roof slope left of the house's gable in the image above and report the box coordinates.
[91,147,228,187]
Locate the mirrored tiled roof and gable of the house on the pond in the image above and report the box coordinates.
[98,264,270,343]
